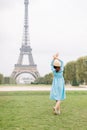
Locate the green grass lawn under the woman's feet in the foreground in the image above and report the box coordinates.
[0,91,87,130]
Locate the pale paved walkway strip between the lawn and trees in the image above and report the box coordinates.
[0,86,87,91]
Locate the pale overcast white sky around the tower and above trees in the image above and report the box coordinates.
[0,0,87,76]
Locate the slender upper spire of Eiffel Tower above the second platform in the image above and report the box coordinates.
[22,0,30,46]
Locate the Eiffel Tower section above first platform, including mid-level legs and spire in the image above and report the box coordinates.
[17,0,35,65]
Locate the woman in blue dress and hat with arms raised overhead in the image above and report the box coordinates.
[50,53,66,114]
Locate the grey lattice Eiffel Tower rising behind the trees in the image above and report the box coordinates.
[11,0,40,83]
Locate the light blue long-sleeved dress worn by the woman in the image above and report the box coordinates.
[50,60,66,100]
